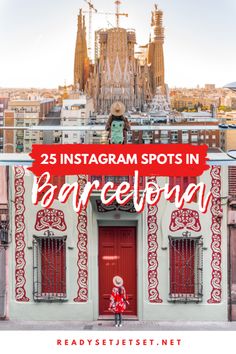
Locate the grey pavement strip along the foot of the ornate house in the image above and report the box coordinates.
[0,320,236,331]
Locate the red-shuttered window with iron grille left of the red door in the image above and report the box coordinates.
[33,232,66,301]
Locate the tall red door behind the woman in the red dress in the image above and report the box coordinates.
[99,226,137,316]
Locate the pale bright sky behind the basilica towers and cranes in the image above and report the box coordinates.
[0,0,236,87]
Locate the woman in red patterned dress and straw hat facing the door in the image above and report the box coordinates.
[109,275,129,327]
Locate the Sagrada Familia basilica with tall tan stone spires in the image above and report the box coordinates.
[74,2,166,114]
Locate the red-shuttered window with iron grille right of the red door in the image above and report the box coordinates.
[169,236,203,302]
